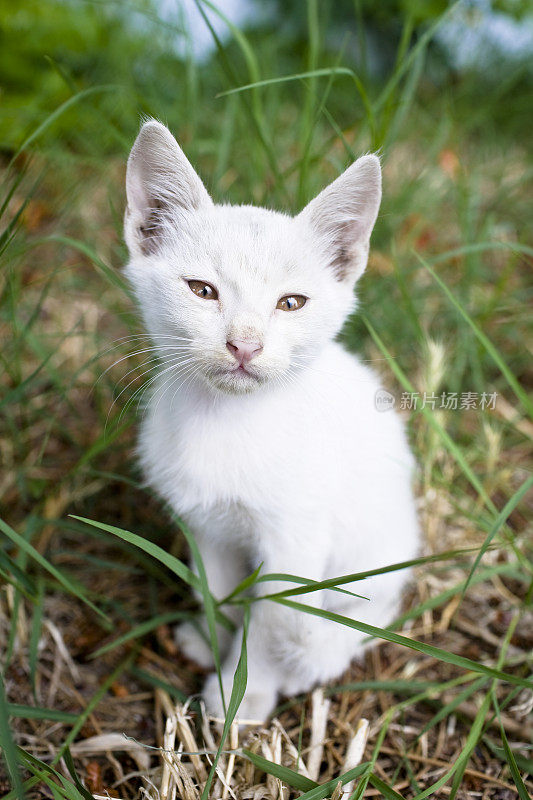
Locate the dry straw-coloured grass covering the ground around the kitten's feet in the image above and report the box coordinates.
[0,494,533,800]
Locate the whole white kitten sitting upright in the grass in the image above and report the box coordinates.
[125,121,418,719]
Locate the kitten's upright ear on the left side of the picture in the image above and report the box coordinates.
[124,120,212,255]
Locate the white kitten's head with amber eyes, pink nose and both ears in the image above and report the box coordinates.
[125,121,381,393]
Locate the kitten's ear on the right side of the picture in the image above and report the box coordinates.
[299,155,381,284]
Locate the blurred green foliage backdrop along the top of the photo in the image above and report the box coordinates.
[0,0,529,157]
